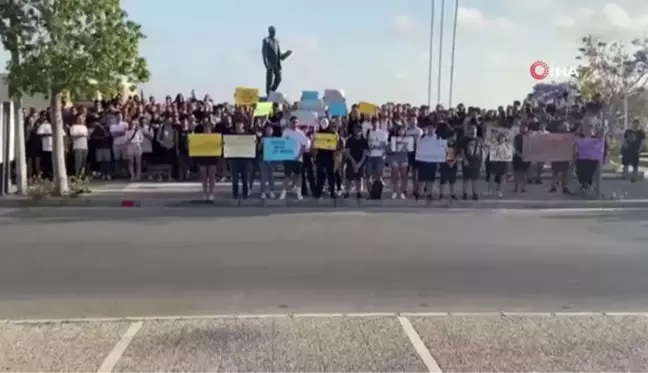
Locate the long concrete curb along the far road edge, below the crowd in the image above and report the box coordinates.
[0,196,648,210]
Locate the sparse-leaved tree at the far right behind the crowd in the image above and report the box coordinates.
[576,35,648,131]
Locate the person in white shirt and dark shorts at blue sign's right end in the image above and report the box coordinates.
[279,116,310,200]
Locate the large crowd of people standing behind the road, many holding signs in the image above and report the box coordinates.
[24,94,645,200]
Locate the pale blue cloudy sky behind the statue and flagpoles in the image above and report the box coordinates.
[0,0,648,107]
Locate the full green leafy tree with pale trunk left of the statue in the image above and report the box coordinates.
[8,0,149,194]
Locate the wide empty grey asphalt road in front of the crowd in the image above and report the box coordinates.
[0,208,648,319]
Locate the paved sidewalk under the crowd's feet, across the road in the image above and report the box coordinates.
[0,180,648,208]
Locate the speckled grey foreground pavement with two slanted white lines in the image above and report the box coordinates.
[0,314,648,373]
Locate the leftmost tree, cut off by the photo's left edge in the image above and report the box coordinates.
[0,0,34,194]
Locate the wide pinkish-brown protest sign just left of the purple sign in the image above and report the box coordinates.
[522,132,574,162]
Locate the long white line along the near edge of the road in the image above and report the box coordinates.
[5,311,648,325]
